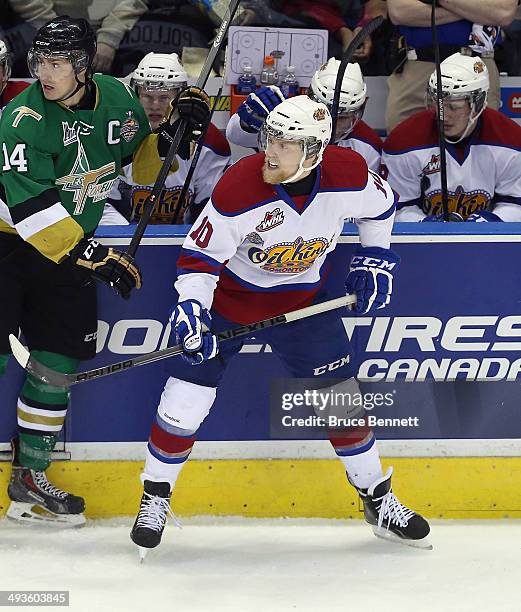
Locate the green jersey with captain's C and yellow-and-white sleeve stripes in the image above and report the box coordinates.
[0,74,150,261]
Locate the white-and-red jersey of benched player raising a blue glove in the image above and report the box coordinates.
[226,113,382,172]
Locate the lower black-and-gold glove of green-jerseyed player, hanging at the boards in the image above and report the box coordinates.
[70,238,142,300]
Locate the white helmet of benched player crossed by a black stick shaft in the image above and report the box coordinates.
[308,57,367,140]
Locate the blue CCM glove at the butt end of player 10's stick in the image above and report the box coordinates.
[346,247,400,314]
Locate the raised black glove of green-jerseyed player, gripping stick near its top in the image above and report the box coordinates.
[157,87,210,159]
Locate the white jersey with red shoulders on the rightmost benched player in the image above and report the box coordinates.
[382,109,521,221]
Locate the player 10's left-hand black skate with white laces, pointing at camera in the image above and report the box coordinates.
[130,480,173,561]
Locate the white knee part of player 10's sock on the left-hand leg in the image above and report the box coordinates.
[157,377,217,435]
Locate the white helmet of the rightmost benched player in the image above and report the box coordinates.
[427,53,490,143]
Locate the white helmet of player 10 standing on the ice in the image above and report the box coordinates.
[259,96,332,183]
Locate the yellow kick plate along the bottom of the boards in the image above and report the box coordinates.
[0,457,521,519]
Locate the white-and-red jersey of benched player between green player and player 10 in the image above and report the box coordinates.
[109,124,231,224]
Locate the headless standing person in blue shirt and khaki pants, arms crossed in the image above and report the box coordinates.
[386,0,517,132]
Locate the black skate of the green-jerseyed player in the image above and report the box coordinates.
[6,464,85,527]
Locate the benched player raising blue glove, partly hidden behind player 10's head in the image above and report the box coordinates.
[226,57,382,172]
